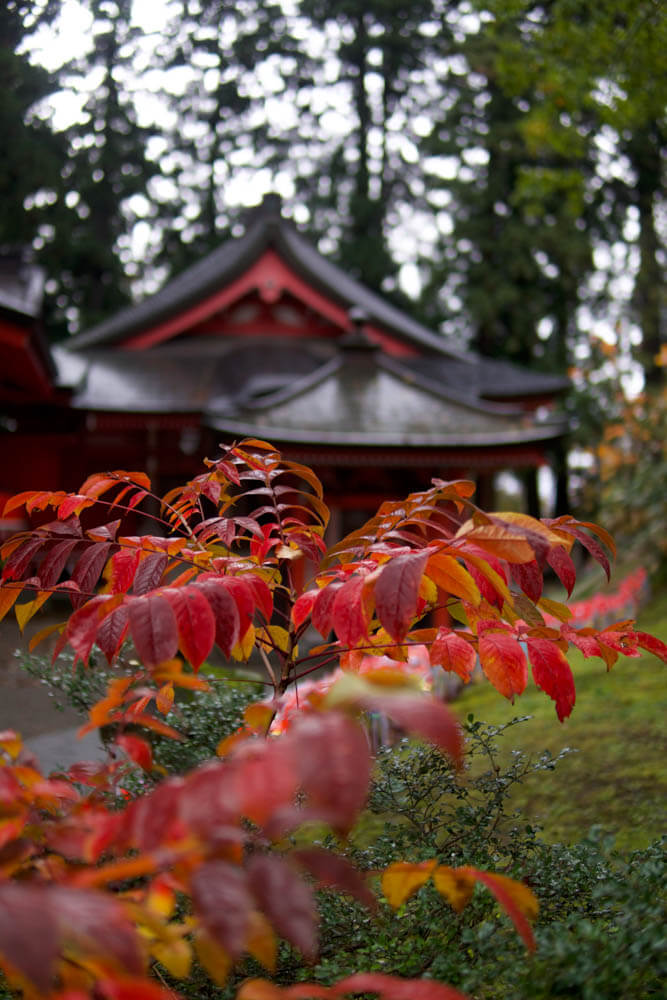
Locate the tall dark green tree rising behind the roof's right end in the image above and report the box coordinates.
[422,3,592,371]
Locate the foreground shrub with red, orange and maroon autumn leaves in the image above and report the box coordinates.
[0,441,665,1000]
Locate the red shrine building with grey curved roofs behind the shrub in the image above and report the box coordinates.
[0,196,568,534]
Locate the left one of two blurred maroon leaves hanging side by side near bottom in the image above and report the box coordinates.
[190,861,254,958]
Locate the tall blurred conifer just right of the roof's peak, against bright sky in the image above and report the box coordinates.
[297,0,448,296]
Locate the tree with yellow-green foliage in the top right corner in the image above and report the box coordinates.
[472,0,667,382]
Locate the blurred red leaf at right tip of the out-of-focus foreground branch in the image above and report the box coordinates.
[365,694,463,765]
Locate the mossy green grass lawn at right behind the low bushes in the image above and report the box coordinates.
[454,588,667,850]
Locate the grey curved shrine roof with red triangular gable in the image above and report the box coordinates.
[53,199,568,448]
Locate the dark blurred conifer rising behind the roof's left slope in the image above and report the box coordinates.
[48,0,158,336]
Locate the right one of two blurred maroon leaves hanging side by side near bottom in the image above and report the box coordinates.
[248,854,317,959]
